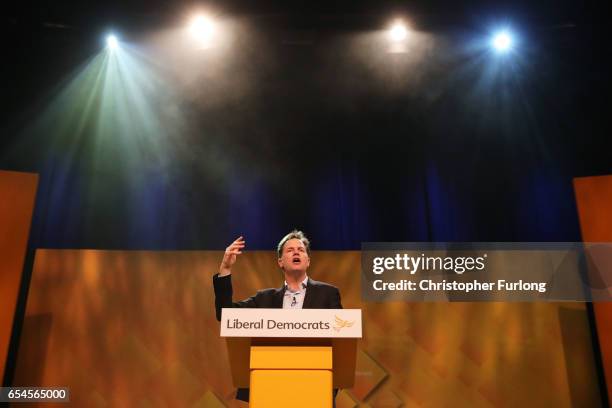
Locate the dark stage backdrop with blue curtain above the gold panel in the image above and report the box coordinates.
[0,10,612,250]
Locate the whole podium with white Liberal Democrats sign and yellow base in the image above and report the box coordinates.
[221,308,362,408]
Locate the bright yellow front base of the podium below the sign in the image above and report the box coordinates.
[249,346,333,408]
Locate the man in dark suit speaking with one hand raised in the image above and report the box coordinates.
[213,230,342,401]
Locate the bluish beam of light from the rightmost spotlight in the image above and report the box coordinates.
[448,24,541,148]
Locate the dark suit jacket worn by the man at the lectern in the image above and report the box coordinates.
[213,274,342,401]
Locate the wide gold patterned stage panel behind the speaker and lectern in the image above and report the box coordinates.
[15,250,598,408]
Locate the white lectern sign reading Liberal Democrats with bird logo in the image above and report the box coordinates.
[221,308,362,338]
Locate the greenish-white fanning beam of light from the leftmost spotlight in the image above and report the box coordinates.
[2,44,192,239]
